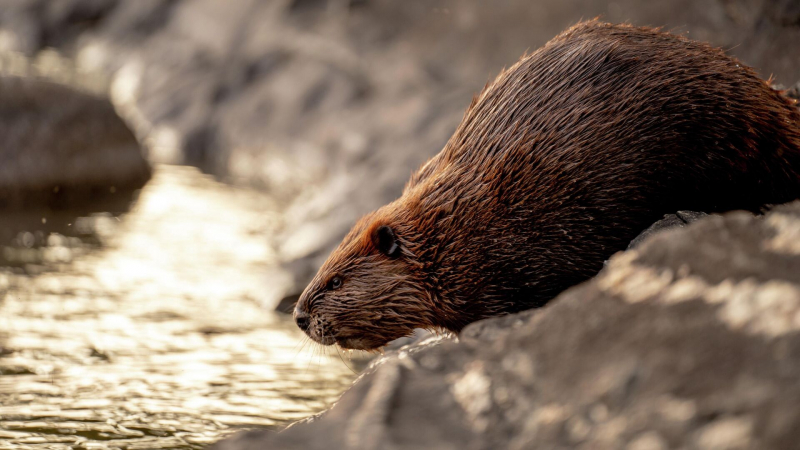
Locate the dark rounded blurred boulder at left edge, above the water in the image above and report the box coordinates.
[0,76,150,207]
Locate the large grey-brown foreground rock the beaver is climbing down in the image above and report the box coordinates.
[214,202,800,450]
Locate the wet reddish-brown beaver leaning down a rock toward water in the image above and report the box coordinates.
[294,20,800,350]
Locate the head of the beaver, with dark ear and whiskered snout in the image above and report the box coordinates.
[294,206,434,350]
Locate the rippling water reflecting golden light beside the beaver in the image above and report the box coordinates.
[0,166,355,449]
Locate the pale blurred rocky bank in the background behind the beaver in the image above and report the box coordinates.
[0,0,800,307]
